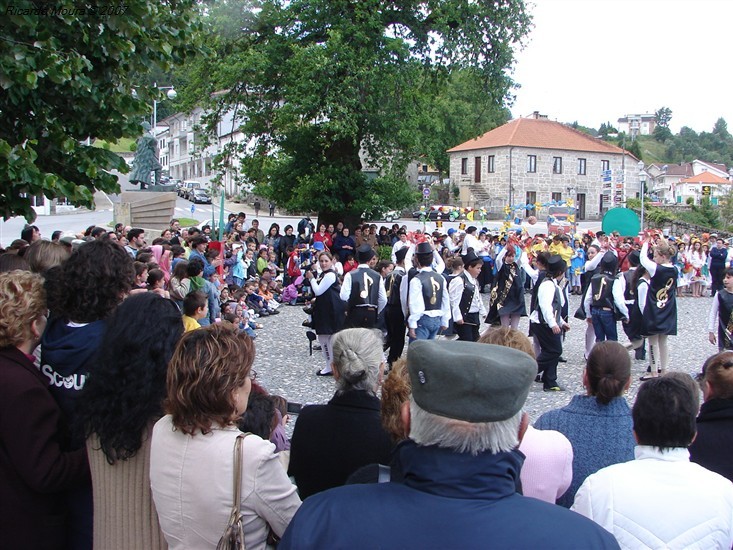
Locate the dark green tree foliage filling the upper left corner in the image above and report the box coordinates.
[0,0,200,220]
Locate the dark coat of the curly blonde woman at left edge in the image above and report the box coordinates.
[0,348,91,550]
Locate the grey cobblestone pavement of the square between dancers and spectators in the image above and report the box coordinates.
[254,295,717,421]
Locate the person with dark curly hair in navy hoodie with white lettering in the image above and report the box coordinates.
[41,239,135,548]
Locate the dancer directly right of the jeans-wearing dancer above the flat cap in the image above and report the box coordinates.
[448,250,486,342]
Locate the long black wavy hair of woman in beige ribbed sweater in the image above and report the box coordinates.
[76,296,183,464]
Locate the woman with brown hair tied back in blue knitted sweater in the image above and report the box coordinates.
[534,341,635,508]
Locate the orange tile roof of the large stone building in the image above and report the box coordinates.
[448,118,633,156]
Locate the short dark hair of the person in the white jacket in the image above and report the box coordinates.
[631,372,699,451]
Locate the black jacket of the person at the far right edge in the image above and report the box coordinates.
[690,399,733,481]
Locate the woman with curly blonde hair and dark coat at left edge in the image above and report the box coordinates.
[0,271,89,549]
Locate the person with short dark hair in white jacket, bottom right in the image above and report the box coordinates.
[571,372,733,549]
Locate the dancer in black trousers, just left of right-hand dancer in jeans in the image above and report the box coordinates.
[529,255,570,391]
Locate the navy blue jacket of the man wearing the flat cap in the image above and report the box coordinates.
[278,441,618,550]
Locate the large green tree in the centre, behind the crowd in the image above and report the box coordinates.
[181,0,530,225]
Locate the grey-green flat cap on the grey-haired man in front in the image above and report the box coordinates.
[407,340,537,422]
